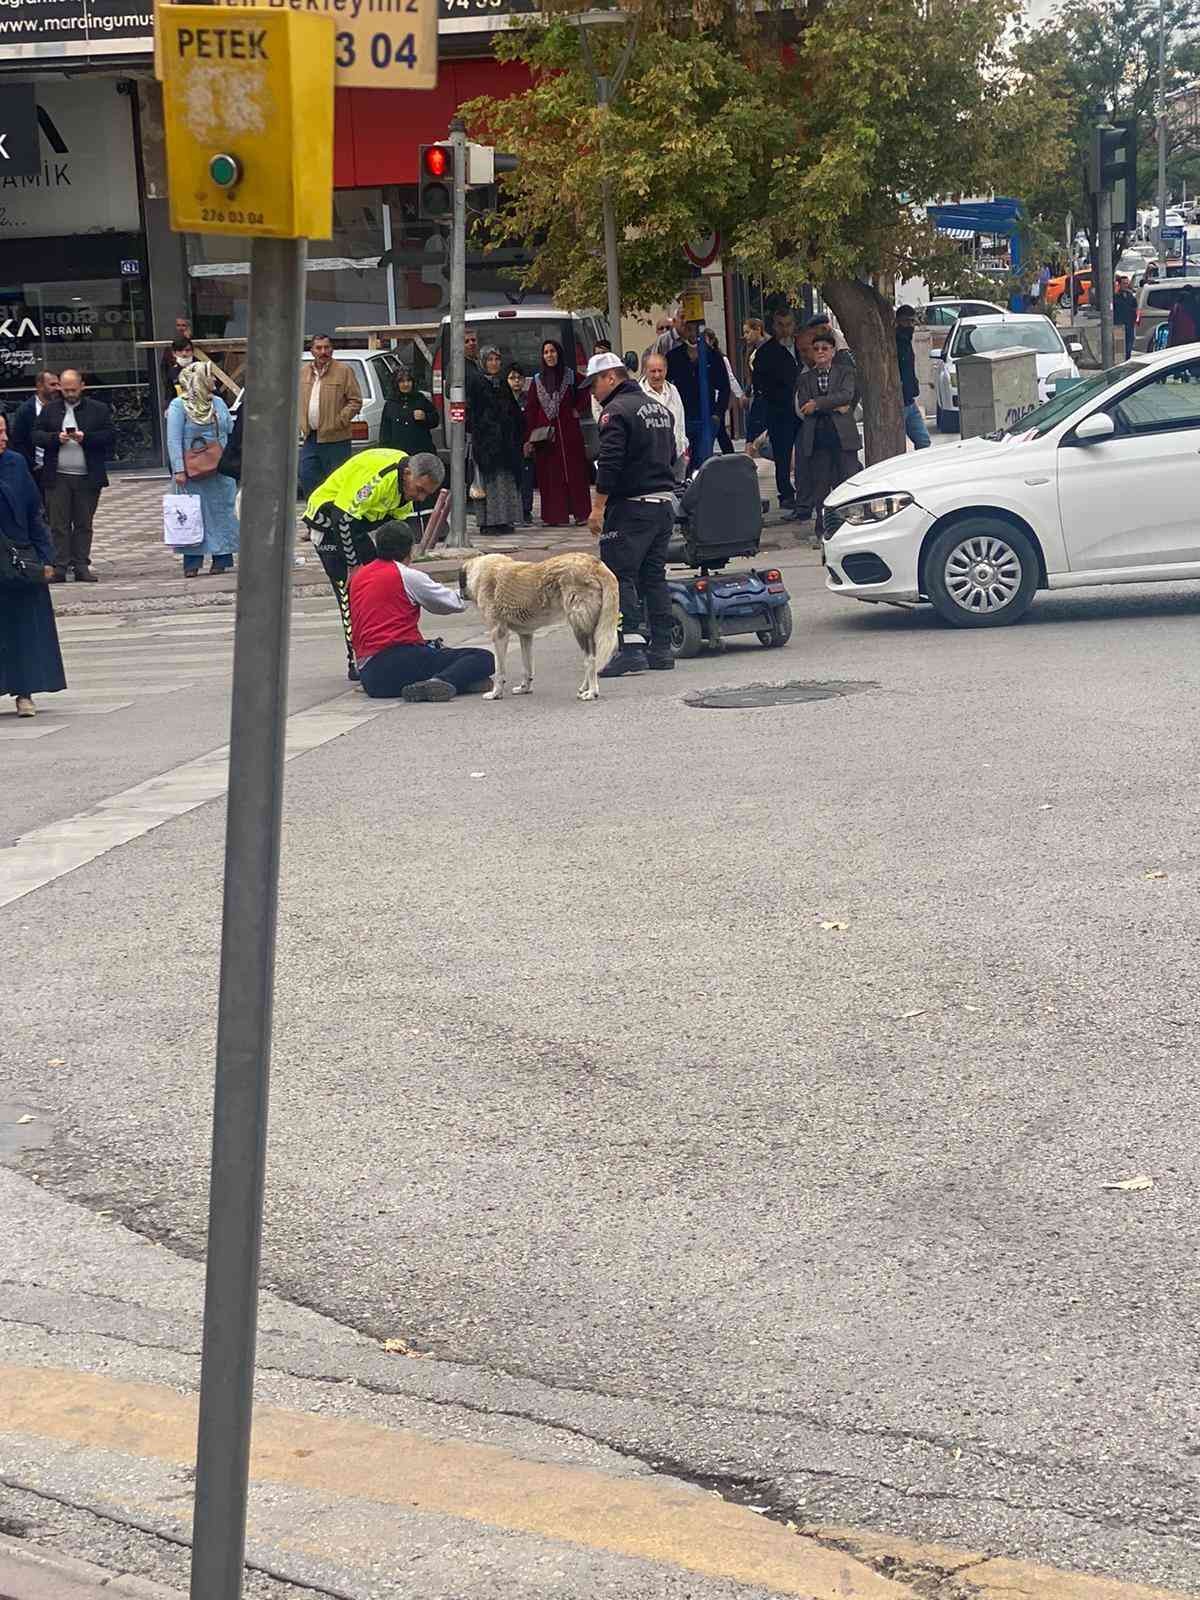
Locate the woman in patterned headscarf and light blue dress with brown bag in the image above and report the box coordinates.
[166,362,238,578]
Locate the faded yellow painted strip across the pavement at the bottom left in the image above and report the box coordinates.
[0,1365,914,1600]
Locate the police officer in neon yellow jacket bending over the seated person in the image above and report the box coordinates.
[304,450,446,683]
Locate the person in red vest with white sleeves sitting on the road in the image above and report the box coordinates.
[350,522,496,701]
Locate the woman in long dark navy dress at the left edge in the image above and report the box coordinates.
[0,416,67,717]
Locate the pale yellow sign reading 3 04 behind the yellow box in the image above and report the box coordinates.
[216,0,437,90]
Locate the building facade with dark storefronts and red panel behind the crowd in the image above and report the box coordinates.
[0,0,533,469]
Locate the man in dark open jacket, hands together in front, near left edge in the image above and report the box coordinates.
[34,368,117,584]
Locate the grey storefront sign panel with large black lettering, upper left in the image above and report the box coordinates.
[0,78,141,236]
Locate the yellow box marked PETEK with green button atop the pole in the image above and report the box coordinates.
[158,5,334,238]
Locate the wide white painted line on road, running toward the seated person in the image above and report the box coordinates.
[0,691,397,906]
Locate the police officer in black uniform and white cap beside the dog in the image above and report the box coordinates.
[584,352,675,678]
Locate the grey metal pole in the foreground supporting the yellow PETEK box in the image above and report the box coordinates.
[190,238,309,1600]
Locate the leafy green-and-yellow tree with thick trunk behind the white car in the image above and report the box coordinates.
[464,0,1064,461]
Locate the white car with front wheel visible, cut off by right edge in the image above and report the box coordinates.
[824,344,1200,627]
